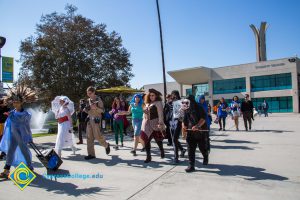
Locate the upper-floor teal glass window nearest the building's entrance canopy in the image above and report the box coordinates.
[213,78,246,94]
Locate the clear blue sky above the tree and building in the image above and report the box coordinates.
[0,0,300,88]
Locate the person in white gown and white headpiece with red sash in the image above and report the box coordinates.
[55,96,76,157]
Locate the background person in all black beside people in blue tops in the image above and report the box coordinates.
[241,94,254,131]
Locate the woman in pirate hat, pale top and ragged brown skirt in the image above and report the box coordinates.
[141,89,166,163]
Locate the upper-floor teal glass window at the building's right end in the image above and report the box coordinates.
[250,73,292,92]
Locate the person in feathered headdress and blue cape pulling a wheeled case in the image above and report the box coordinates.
[0,85,37,179]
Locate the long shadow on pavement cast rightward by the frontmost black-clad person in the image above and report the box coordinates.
[199,163,288,181]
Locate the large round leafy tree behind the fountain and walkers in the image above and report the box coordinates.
[19,5,133,108]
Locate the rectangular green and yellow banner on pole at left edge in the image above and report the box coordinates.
[2,56,14,83]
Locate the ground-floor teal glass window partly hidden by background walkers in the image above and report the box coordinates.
[251,97,293,113]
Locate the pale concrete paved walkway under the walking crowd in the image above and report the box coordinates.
[0,114,300,200]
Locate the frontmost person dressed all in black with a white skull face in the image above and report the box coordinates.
[182,95,209,172]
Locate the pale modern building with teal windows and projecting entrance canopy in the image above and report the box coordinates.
[168,57,300,113]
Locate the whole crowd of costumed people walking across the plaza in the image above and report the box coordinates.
[0,86,268,178]
